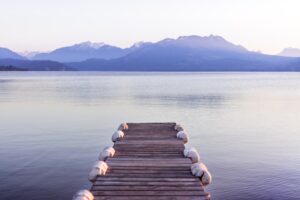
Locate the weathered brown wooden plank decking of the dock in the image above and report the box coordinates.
[91,123,210,200]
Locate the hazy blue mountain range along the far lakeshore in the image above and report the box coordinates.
[0,35,300,71]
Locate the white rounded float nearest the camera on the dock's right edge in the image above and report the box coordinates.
[191,163,212,185]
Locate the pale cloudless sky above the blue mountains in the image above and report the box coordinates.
[0,0,300,54]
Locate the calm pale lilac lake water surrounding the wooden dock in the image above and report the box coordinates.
[0,72,300,200]
